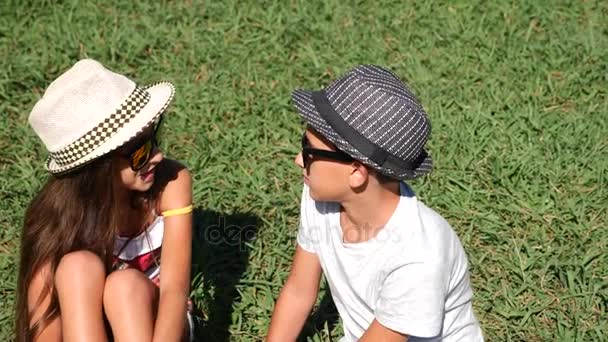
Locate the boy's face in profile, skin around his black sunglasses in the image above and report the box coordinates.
[295,128,356,202]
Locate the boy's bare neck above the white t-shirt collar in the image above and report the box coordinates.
[340,182,400,243]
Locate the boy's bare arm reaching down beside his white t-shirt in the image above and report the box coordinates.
[267,245,322,342]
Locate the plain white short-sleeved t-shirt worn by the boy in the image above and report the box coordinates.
[297,183,483,342]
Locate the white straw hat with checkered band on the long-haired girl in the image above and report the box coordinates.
[29,59,175,174]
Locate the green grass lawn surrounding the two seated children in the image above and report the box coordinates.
[0,0,608,341]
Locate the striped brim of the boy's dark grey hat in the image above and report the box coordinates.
[291,89,433,180]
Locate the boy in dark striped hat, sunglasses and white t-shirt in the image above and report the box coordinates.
[268,65,483,342]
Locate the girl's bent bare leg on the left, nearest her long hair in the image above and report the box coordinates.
[55,251,108,342]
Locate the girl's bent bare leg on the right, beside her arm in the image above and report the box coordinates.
[103,269,159,342]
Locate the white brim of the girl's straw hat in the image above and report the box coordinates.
[46,82,175,174]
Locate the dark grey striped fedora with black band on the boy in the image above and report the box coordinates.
[292,65,433,180]
